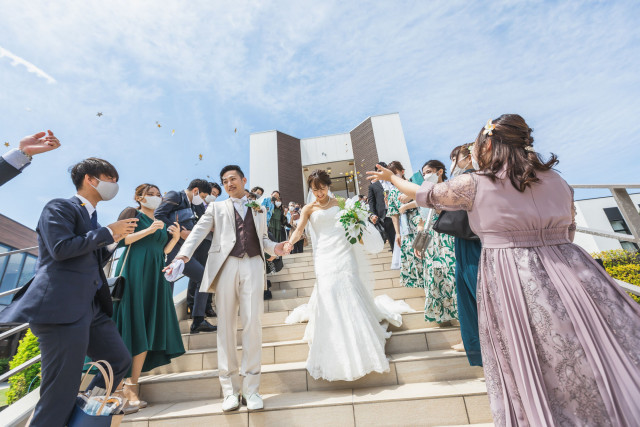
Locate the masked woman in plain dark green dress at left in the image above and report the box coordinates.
[113,184,185,408]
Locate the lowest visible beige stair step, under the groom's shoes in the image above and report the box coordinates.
[123,379,491,427]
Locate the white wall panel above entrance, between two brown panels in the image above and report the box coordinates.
[300,133,353,166]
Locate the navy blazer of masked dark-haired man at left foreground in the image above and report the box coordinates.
[0,197,113,324]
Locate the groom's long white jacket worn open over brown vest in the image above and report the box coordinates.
[177,199,276,292]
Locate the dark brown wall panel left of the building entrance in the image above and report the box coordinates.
[277,132,305,205]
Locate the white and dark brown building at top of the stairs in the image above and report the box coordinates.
[250,113,413,203]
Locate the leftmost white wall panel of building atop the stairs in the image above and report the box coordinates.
[247,131,279,194]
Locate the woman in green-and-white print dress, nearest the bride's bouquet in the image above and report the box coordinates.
[387,161,424,288]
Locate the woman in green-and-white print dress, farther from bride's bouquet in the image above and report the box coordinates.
[420,160,458,326]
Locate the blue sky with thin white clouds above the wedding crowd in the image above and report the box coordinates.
[0,0,640,231]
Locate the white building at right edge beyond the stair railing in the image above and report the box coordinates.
[575,193,640,253]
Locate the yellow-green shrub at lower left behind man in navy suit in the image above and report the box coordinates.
[7,329,40,405]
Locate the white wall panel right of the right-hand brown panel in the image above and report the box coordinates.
[371,113,421,178]
